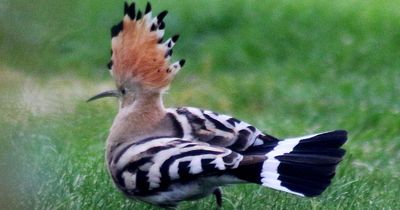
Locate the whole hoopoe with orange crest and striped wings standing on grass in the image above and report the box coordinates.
[89,3,347,208]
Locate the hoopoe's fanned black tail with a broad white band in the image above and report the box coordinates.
[234,130,347,197]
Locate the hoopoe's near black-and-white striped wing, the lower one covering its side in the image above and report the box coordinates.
[111,137,243,196]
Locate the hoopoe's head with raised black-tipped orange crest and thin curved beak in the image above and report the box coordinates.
[88,3,185,107]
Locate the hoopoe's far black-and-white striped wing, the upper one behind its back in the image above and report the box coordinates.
[168,107,278,153]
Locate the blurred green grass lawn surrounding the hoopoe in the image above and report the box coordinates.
[0,0,400,209]
